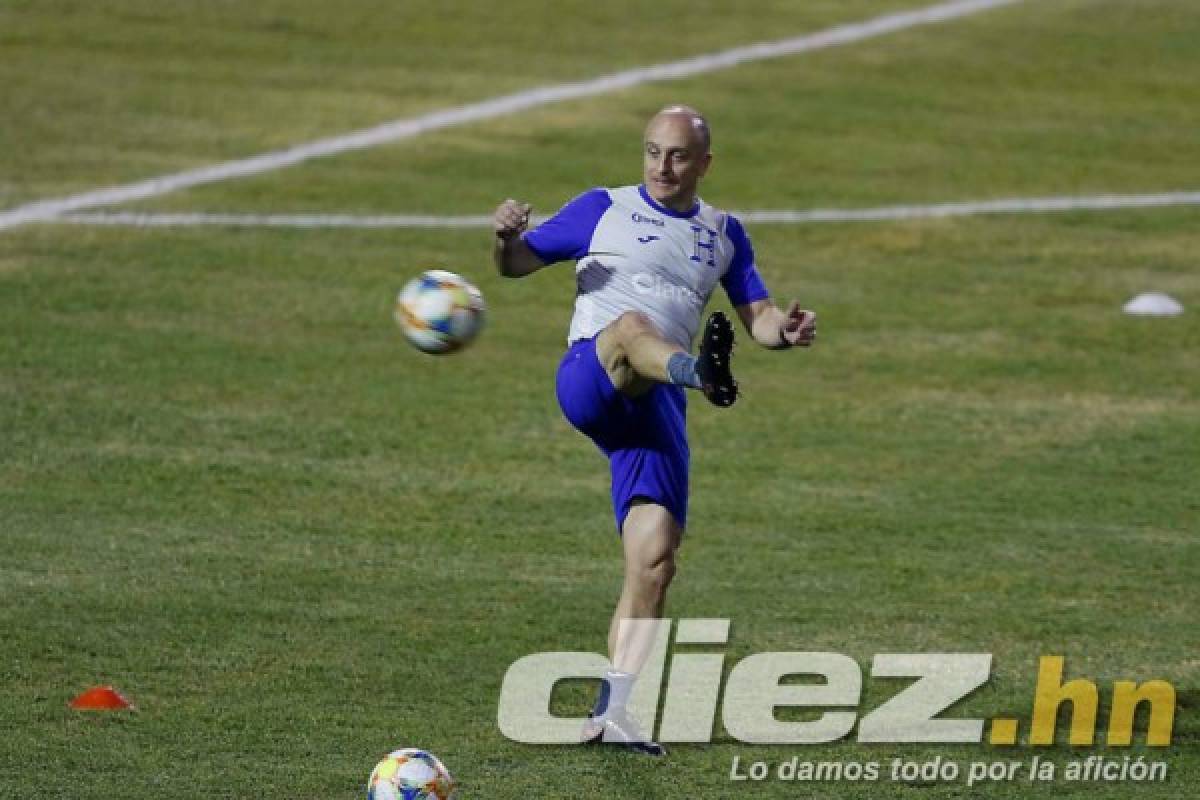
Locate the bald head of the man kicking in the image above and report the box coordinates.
[642,106,713,211]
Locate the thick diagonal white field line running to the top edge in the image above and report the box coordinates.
[0,0,1022,230]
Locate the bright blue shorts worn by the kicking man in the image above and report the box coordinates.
[557,338,691,533]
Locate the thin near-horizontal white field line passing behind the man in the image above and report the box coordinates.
[58,192,1200,228]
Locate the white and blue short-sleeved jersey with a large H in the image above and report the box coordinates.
[522,186,767,350]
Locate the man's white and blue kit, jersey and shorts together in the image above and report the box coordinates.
[523,186,767,531]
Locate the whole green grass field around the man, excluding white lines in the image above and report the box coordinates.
[0,0,1200,799]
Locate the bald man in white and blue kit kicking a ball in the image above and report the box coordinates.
[493,106,816,756]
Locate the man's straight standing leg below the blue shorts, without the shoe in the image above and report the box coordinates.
[608,503,683,673]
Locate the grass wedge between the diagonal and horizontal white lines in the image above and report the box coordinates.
[105,1,1200,213]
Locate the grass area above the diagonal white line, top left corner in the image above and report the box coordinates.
[0,0,907,207]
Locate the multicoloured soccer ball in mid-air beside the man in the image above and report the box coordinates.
[392,270,484,354]
